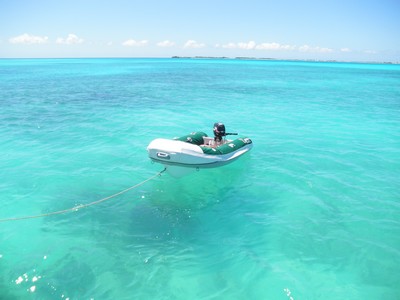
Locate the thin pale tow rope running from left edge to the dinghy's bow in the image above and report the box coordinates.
[0,168,166,223]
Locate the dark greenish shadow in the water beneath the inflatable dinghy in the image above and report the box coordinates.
[125,159,253,243]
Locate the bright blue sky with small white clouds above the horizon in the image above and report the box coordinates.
[0,0,400,62]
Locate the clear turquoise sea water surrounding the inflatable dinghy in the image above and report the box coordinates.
[0,59,400,300]
